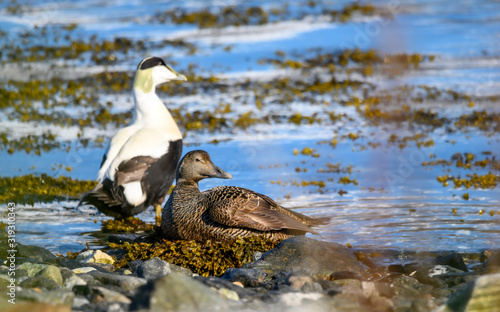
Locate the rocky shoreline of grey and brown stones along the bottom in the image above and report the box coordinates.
[0,228,500,312]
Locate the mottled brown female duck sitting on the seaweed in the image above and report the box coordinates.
[161,150,330,241]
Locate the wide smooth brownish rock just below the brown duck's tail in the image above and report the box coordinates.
[245,236,365,276]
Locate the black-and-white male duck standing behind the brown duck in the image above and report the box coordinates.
[80,57,187,220]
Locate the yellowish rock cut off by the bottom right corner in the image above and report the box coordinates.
[439,273,500,312]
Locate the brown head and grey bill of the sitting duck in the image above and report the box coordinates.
[176,150,232,183]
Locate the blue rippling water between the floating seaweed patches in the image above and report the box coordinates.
[0,1,500,253]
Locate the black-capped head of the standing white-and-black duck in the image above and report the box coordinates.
[134,56,187,93]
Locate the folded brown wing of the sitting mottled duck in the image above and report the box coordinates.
[204,186,316,233]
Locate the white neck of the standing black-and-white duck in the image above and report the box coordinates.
[132,88,182,138]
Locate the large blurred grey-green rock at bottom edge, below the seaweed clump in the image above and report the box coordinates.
[130,272,229,312]
